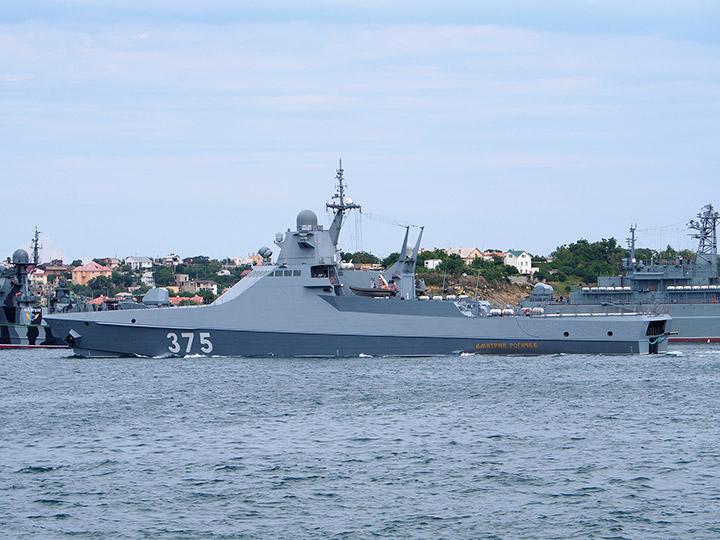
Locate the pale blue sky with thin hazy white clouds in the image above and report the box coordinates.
[0,0,720,262]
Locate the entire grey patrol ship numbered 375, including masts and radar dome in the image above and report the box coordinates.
[47,163,670,357]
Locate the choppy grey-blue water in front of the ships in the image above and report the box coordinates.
[0,345,720,539]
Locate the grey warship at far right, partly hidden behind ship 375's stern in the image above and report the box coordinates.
[521,204,720,343]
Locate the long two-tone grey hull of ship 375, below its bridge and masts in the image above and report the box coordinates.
[49,278,669,357]
